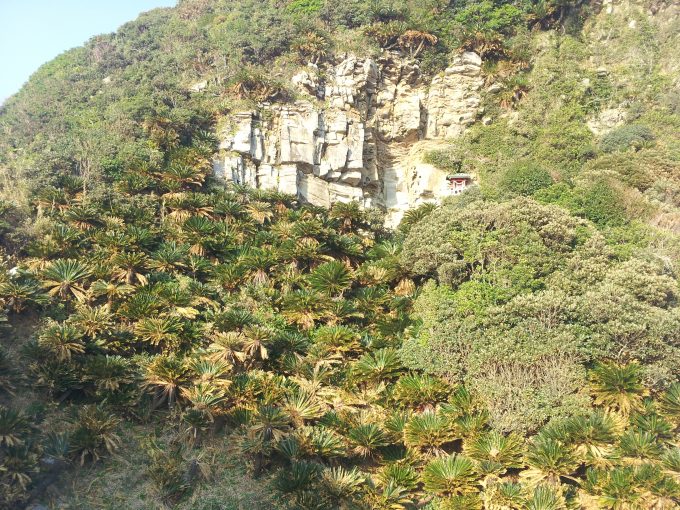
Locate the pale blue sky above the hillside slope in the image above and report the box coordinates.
[0,0,176,104]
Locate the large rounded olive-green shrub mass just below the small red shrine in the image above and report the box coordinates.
[402,199,680,431]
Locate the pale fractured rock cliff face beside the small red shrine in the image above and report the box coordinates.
[214,53,482,225]
